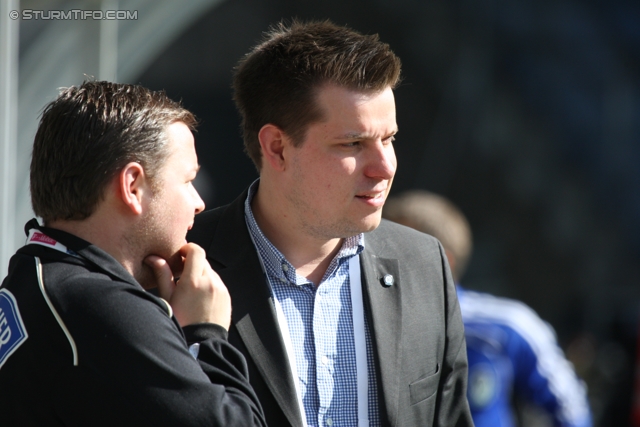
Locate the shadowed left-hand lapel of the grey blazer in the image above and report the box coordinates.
[207,192,303,426]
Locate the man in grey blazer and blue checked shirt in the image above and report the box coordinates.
[188,22,473,427]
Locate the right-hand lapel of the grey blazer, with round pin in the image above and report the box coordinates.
[360,246,402,425]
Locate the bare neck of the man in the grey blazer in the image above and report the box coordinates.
[251,181,343,286]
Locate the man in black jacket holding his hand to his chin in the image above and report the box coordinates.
[0,82,266,427]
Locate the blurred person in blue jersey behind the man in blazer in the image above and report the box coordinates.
[383,190,592,427]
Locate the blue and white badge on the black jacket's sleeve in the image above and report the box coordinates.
[0,289,29,369]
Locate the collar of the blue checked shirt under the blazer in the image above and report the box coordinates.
[244,178,364,285]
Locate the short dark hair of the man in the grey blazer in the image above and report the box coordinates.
[233,20,400,171]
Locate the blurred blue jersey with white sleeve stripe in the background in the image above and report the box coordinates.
[458,287,592,427]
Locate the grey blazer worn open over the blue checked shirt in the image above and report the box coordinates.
[187,191,473,427]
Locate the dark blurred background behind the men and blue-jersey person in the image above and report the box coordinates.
[137,0,640,426]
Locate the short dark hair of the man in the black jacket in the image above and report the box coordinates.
[30,81,196,223]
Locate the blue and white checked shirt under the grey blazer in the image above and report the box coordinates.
[245,181,380,427]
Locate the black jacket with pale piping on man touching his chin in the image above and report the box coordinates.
[0,221,266,427]
